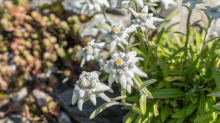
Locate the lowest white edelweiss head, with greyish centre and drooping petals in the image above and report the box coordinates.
[72,71,113,111]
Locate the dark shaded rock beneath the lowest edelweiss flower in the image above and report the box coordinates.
[58,84,126,123]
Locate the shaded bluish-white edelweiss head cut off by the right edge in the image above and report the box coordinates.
[202,5,220,20]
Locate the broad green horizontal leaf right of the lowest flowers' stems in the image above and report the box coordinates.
[152,88,185,99]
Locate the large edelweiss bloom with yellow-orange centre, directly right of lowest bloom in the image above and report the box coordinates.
[104,51,147,93]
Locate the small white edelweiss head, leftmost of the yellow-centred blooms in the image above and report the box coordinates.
[76,39,105,67]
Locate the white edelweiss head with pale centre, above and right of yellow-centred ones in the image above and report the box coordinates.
[129,6,164,32]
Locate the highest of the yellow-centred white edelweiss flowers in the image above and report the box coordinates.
[102,21,136,53]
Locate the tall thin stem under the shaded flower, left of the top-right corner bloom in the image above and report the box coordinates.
[185,10,192,59]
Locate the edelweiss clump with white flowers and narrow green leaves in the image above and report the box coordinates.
[72,0,220,123]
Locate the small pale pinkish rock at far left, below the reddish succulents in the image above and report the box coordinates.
[12,87,28,102]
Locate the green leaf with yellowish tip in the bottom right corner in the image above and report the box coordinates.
[194,112,217,123]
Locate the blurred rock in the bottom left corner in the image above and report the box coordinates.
[0,113,37,123]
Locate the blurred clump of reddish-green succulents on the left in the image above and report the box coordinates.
[0,1,91,120]
